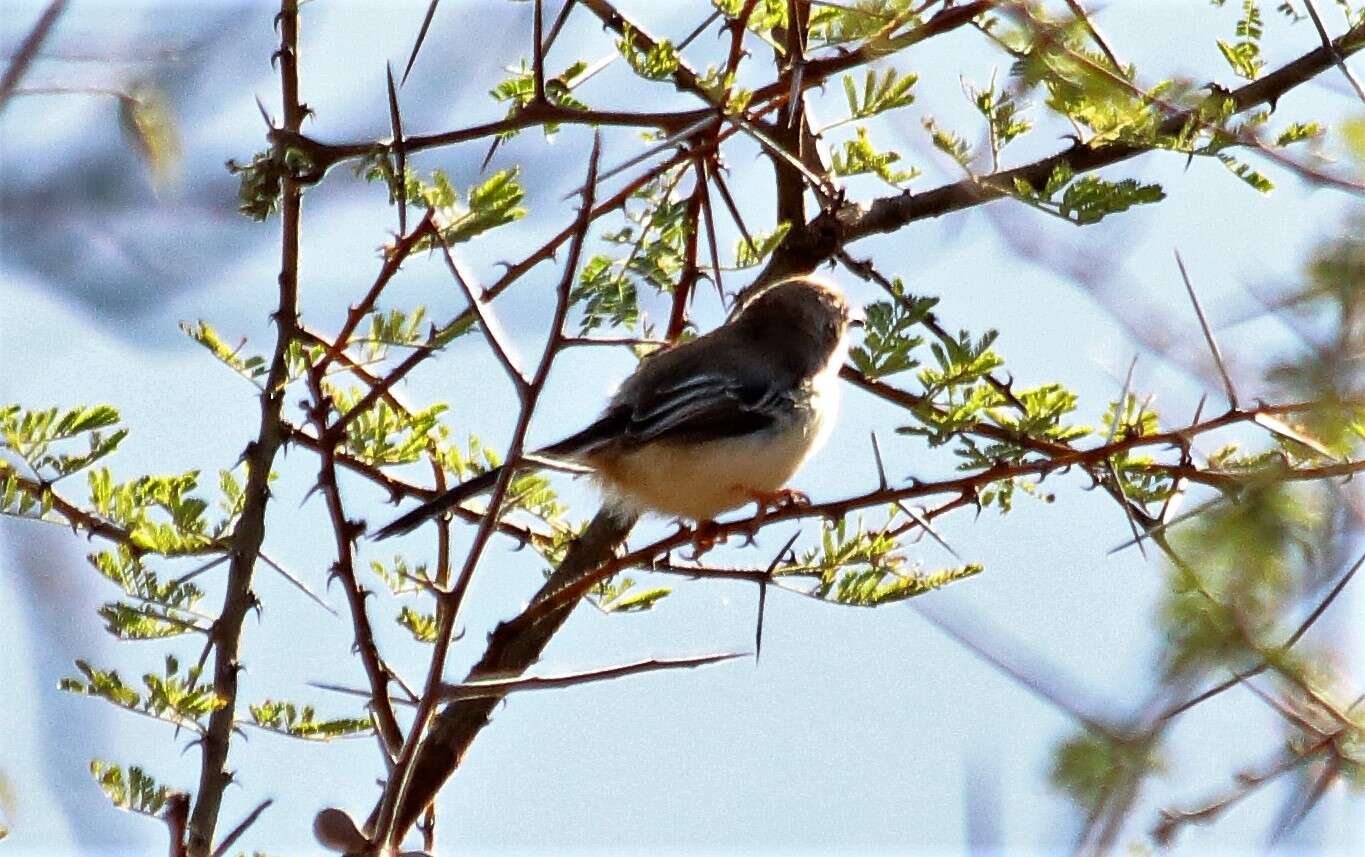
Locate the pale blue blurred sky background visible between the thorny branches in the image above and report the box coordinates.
[0,0,1365,856]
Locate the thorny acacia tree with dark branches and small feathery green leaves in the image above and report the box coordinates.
[0,0,1365,857]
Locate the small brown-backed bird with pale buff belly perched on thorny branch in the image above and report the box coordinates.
[374,277,863,539]
